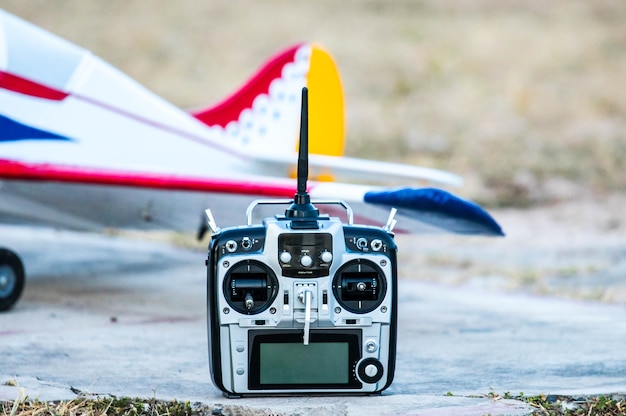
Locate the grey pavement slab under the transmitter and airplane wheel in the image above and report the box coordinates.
[0,226,626,415]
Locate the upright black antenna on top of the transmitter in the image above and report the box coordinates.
[285,87,320,224]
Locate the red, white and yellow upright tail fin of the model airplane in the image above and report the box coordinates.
[192,43,345,161]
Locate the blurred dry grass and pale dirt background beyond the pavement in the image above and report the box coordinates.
[0,0,626,304]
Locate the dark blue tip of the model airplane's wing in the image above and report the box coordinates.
[364,188,504,236]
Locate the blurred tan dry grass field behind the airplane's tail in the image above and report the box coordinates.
[3,0,626,206]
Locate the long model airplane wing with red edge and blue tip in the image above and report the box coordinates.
[0,163,503,236]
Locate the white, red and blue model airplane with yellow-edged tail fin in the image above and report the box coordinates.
[0,10,502,310]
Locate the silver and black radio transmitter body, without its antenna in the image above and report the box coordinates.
[206,202,397,397]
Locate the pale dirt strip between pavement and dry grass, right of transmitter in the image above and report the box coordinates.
[396,193,626,305]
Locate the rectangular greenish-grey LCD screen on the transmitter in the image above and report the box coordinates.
[259,342,351,385]
